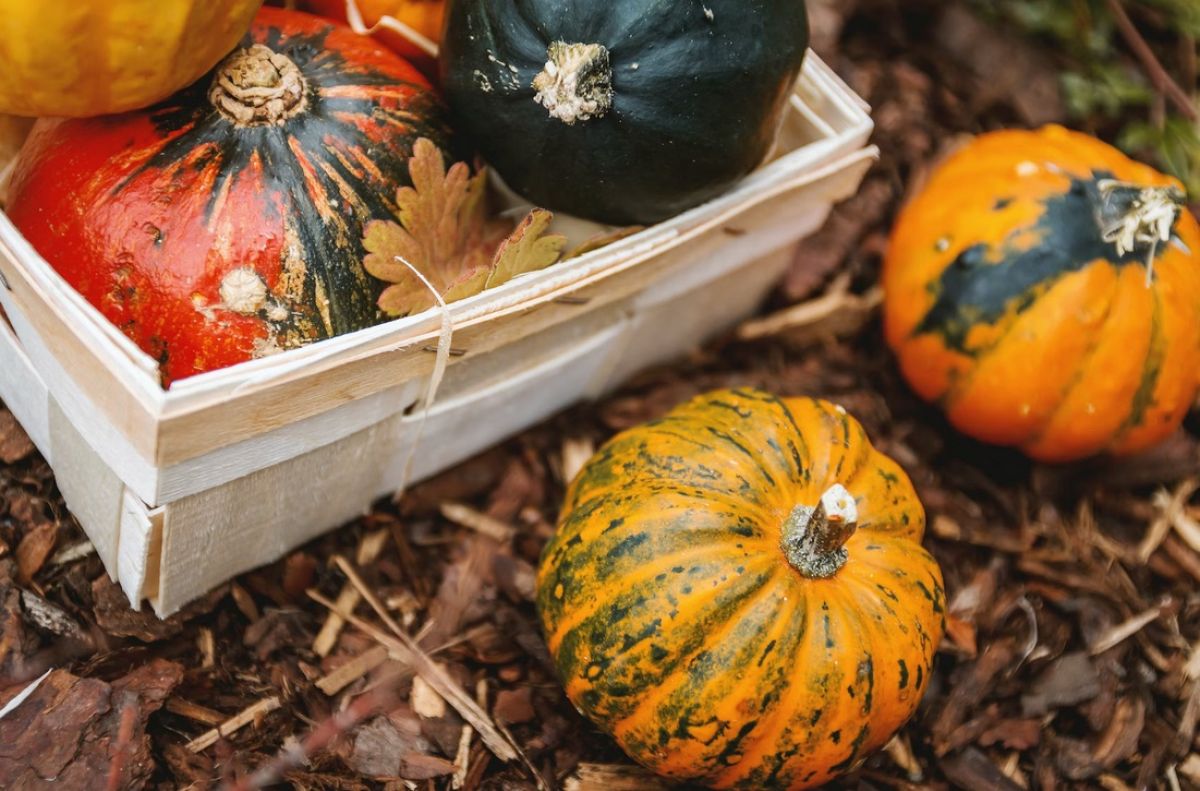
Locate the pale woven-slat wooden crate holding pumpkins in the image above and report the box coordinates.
[0,53,877,616]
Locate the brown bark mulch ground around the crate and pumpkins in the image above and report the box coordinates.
[0,0,1200,791]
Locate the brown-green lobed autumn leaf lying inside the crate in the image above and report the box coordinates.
[362,138,566,316]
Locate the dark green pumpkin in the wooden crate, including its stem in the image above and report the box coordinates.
[440,0,809,224]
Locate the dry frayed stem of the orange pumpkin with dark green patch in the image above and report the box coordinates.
[1096,179,1187,286]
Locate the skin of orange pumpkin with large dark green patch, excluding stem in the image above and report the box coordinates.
[883,127,1200,462]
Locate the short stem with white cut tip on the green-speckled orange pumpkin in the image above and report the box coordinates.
[784,484,858,580]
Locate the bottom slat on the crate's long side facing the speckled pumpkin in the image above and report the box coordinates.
[145,320,625,616]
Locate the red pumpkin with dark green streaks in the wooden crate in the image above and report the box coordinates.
[8,8,449,383]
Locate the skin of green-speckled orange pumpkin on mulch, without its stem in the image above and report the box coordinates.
[538,390,944,790]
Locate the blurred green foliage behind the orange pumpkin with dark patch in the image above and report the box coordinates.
[976,0,1200,198]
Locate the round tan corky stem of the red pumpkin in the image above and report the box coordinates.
[209,44,308,126]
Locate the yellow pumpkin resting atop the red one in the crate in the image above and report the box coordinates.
[0,0,262,118]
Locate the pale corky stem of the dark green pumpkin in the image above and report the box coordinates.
[533,41,612,126]
